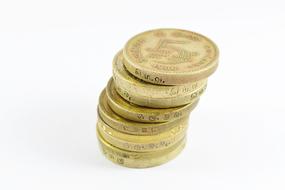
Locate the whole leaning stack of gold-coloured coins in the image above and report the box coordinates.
[97,29,218,168]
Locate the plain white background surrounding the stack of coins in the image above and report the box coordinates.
[0,0,285,190]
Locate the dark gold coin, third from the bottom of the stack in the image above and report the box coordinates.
[98,89,189,135]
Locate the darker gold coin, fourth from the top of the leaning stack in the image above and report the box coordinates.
[106,79,198,123]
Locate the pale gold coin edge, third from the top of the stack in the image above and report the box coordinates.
[115,81,207,108]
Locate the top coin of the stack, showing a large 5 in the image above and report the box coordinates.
[123,29,219,85]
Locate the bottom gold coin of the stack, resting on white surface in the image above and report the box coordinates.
[97,131,186,168]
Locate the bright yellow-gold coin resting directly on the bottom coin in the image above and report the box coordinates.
[97,117,188,152]
